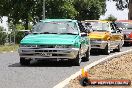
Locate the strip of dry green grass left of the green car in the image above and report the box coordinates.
[0,44,19,53]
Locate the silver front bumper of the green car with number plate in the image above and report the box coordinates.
[18,48,79,60]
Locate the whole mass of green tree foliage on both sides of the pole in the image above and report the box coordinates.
[0,0,106,29]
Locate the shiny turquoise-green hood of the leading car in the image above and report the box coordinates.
[21,34,79,45]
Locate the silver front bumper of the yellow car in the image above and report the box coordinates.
[91,40,108,49]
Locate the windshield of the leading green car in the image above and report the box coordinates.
[32,22,78,34]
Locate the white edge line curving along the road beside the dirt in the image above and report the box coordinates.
[53,49,132,88]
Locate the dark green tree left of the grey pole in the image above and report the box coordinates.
[0,0,42,29]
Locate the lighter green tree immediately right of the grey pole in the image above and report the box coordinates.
[46,0,77,19]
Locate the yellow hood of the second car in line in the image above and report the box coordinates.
[89,32,109,39]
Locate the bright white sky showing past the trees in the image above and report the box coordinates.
[0,1,128,29]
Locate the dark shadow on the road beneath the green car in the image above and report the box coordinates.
[8,61,72,67]
